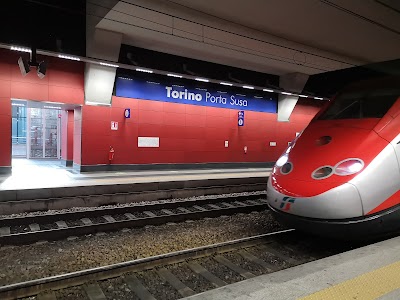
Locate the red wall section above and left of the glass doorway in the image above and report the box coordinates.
[0,49,84,167]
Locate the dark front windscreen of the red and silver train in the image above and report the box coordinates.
[318,90,400,120]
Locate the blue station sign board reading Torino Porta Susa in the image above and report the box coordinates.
[116,77,277,113]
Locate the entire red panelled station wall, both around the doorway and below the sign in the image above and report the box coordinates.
[0,50,321,168]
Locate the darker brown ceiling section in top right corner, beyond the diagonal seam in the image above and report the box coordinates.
[169,0,400,62]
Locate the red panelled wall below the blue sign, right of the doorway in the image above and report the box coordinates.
[82,97,319,165]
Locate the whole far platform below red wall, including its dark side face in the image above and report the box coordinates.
[0,160,271,202]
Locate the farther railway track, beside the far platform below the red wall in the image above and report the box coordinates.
[0,192,268,245]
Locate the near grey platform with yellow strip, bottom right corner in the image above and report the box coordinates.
[185,237,400,300]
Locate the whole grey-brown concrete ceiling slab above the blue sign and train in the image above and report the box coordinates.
[91,0,400,75]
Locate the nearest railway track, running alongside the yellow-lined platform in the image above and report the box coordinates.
[0,229,351,300]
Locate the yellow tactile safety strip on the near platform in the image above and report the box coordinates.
[299,261,400,300]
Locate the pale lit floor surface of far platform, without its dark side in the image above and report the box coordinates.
[0,158,271,191]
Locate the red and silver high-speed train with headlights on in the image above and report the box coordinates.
[267,78,400,239]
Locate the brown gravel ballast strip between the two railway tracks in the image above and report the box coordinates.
[0,211,283,286]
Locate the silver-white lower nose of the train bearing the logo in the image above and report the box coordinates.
[267,177,363,219]
